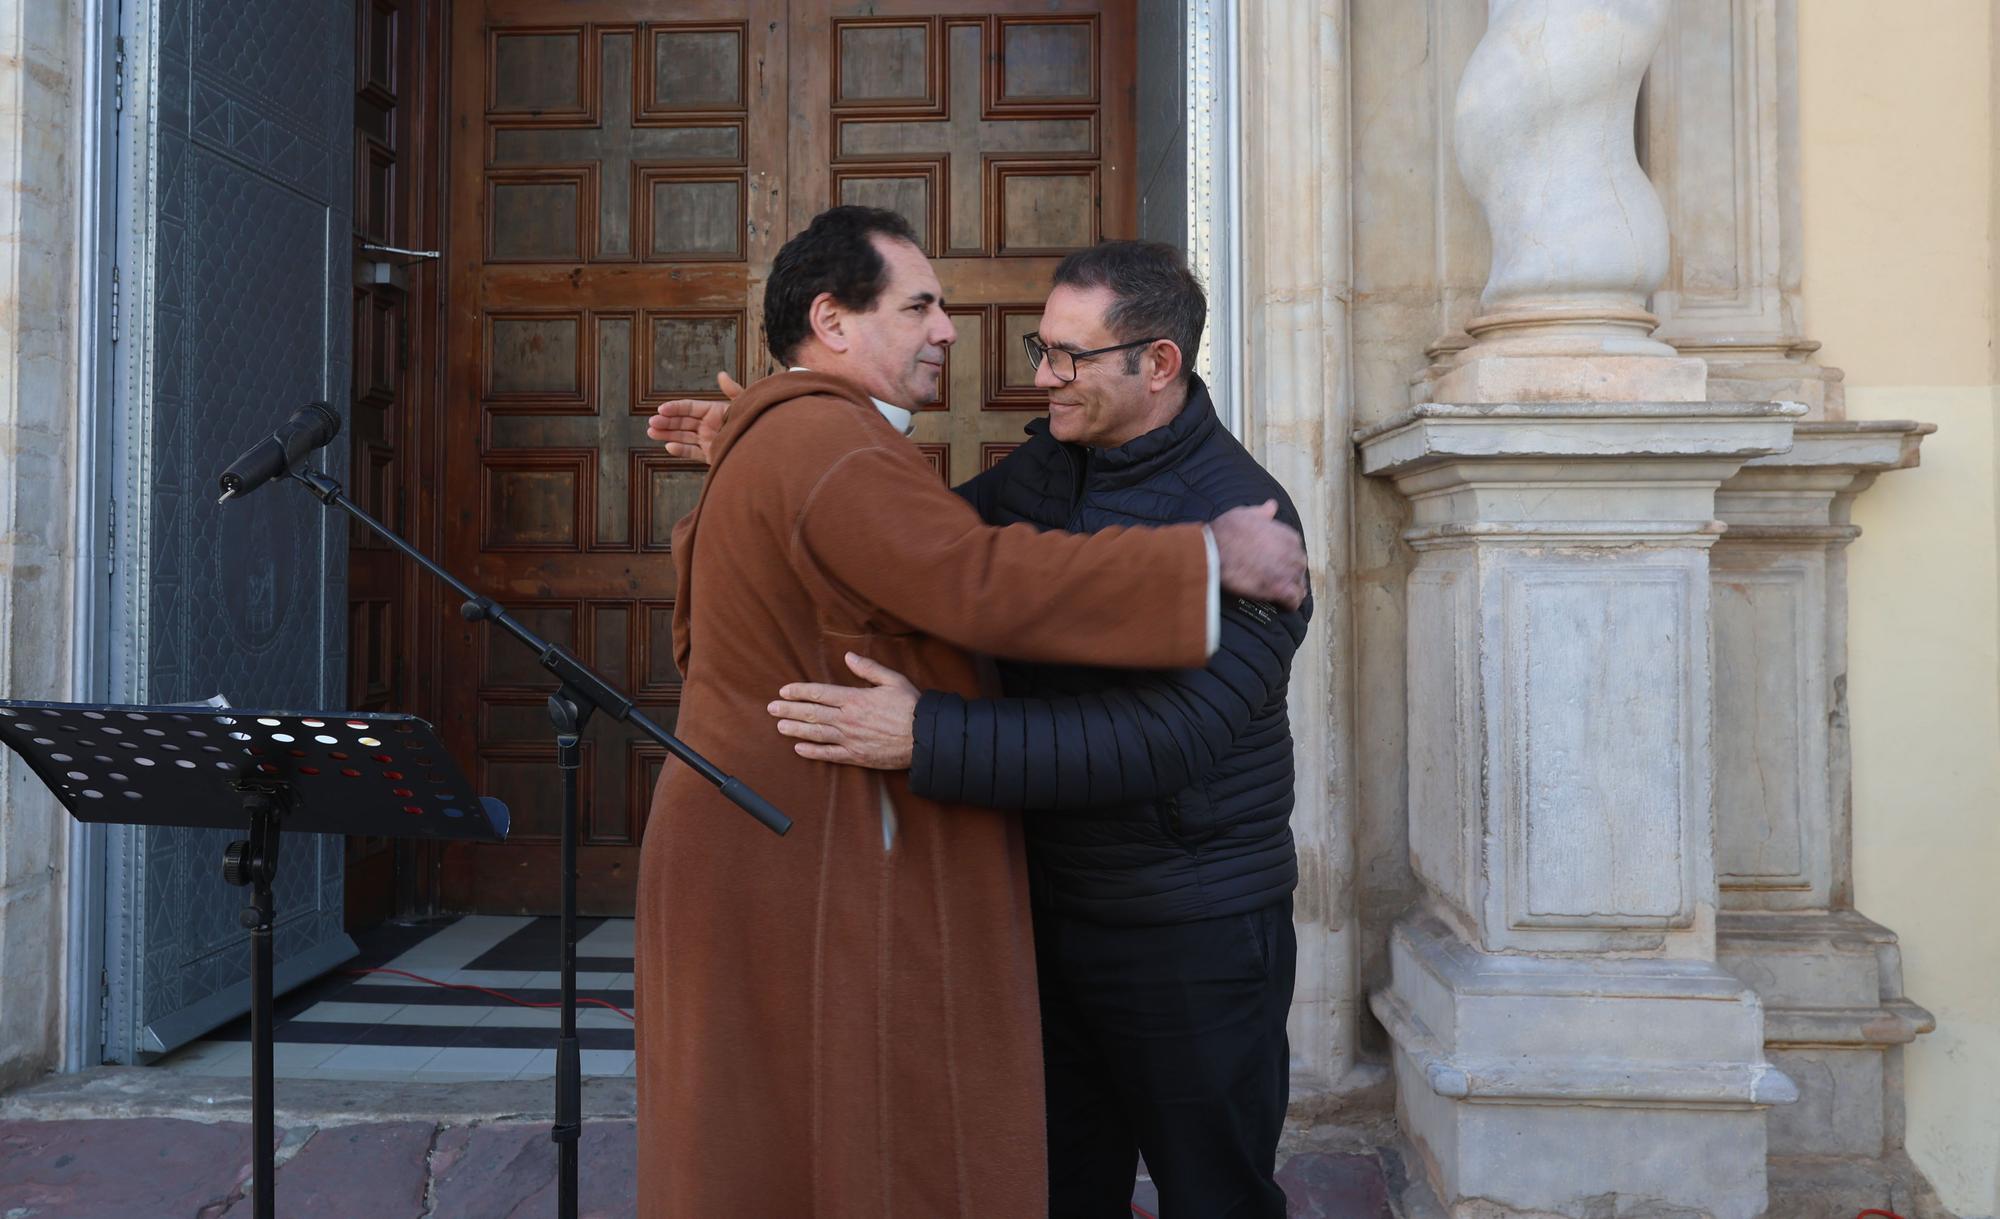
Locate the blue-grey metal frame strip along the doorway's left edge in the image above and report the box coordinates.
[89,0,354,1069]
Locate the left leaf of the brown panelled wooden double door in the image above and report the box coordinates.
[444,0,786,913]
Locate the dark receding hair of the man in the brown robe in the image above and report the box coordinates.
[764,206,916,364]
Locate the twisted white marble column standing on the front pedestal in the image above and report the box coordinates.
[1428,0,1706,402]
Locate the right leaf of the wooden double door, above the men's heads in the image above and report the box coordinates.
[792,0,1138,484]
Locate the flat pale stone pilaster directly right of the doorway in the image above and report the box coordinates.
[1232,0,1388,1121]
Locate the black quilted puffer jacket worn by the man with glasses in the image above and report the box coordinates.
[910,380,1312,925]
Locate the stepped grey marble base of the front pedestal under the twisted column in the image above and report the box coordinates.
[1372,915,1796,1219]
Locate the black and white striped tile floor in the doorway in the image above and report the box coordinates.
[156,915,634,1083]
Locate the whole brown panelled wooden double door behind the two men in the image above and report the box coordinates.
[438,0,1136,913]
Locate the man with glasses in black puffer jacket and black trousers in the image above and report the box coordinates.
[772,242,1312,1219]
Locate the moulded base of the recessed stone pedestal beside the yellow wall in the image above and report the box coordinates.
[1716,909,1936,1159]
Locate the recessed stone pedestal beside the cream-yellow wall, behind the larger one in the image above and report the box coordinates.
[1710,422,1934,1213]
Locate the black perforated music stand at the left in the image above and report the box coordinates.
[0,699,508,1219]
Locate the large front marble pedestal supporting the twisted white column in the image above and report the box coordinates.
[1358,402,1802,1219]
